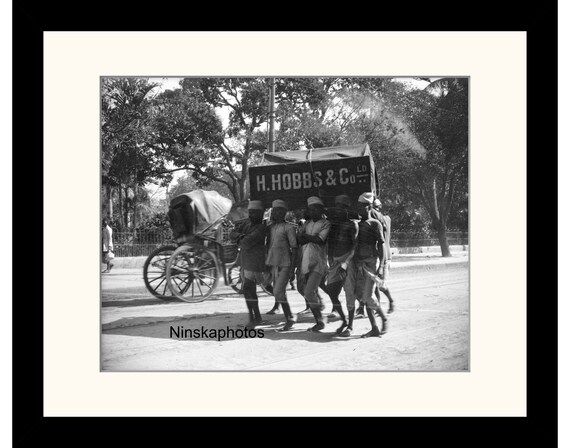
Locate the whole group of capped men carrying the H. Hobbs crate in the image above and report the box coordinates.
[231,192,394,337]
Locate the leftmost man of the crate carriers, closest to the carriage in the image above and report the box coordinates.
[230,201,268,328]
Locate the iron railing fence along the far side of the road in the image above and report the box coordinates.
[106,230,469,257]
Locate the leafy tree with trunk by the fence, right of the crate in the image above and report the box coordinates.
[380,78,469,257]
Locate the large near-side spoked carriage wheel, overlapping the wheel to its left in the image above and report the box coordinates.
[166,245,219,303]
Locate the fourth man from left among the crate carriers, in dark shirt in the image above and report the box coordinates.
[320,194,358,334]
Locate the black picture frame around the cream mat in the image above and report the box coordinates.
[12,1,558,447]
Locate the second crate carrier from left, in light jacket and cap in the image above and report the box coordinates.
[265,199,297,331]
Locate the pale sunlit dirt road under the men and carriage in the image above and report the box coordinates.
[101,263,469,371]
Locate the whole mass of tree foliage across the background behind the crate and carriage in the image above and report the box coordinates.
[101,77,468,254]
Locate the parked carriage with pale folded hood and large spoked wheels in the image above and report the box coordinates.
[143,190,267,303]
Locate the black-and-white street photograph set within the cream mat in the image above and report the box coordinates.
[100,74,472,373]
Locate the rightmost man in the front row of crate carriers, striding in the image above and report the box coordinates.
[340,193,387,337]
